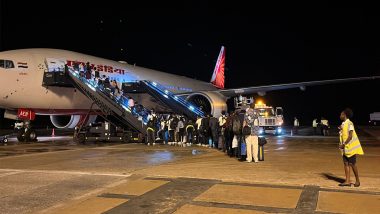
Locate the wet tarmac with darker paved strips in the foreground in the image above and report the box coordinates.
[0,130,380,213]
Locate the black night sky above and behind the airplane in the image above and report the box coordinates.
[0,1,380,125]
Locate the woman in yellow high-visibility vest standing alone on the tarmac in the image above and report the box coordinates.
[339,108,364,187]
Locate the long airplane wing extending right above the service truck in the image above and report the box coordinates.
[211,76,380,97]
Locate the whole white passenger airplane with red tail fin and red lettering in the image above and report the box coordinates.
[0,46,379,140]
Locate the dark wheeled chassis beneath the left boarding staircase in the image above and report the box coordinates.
[74,122,143,143]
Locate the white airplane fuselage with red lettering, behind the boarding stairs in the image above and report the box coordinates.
[0,49,215,115]
